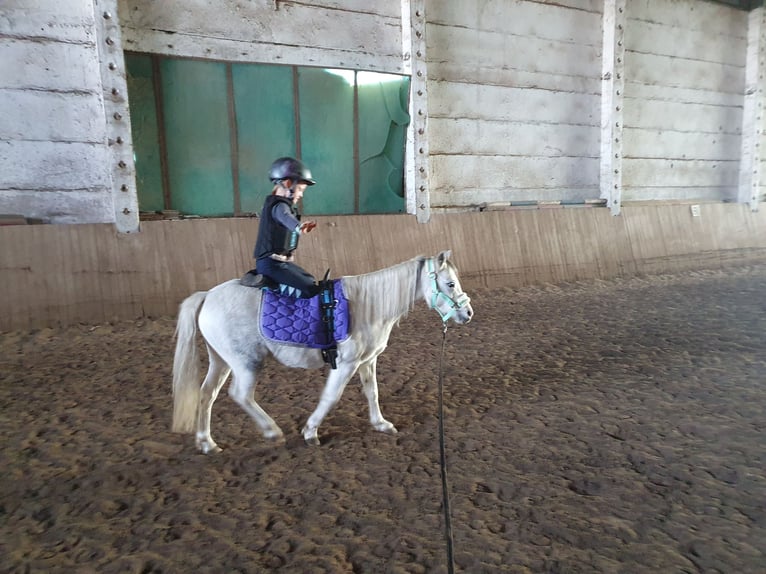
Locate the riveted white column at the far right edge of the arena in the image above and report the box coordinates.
[737,7,766,211]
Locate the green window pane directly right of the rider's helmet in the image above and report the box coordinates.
[298,68,354,214]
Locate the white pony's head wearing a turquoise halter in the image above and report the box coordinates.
[423,250,473,325]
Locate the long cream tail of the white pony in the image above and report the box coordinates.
[172,291,207,433]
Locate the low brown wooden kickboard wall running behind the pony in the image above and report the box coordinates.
[0,204,766,331]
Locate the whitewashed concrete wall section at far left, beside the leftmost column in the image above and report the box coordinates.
[0,0,114,223]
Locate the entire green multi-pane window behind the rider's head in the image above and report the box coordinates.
[126,54,409,216]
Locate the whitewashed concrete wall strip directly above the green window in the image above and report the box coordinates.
[119,0,407,74]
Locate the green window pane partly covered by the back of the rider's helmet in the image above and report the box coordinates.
[232,64,295,213]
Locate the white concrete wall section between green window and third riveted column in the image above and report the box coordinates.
[427,0,603,208]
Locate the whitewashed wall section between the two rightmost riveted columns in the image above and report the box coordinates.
[622,0,748,202]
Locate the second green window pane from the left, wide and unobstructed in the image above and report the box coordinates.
[161,59,234,216]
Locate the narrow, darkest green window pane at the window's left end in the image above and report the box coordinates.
[125,53,165,211]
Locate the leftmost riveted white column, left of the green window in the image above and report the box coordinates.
[93,0,139,233]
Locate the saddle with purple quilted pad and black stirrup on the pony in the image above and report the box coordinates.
[240,269,349,369]
